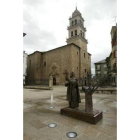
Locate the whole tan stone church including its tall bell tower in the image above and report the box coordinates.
[27,8,91,85]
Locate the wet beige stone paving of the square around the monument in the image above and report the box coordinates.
[23,86,117,140]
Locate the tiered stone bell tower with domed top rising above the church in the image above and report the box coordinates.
[66,7,88,51]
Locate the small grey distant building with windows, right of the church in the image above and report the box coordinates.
[94,59,108,77]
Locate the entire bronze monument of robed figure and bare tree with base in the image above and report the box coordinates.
[60,71,103,124]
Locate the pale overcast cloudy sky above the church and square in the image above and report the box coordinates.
[23,0,117,75]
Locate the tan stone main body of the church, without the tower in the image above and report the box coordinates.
[27,43,91,84]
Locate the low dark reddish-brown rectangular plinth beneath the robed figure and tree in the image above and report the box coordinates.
[60,107,103,124]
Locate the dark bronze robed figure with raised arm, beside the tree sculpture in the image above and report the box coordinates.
[65,72,81,108]
